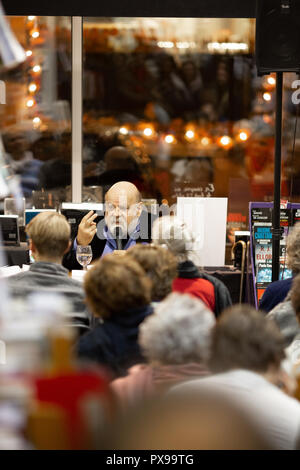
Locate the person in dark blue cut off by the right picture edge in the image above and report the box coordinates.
[259,223,300,312]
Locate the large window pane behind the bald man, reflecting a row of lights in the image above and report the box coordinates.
[83,18,300,261]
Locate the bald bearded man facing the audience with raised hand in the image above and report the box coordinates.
[63,181,148,270]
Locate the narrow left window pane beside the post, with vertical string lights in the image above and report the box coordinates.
[0,16,72,208]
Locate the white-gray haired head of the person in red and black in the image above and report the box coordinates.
[152,215,195,261]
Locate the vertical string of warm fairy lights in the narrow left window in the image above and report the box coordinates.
[25,16,42,128]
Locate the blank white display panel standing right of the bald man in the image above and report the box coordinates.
[177,197,228,266]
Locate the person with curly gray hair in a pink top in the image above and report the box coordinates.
[111,292,215,408]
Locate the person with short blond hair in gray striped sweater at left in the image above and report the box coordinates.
[7,211,90,326]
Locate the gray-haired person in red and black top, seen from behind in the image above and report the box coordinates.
[152,216,232,316]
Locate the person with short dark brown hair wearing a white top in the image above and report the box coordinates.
[174,305,300,449]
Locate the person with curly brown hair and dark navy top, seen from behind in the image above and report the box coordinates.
[77,254,152,377]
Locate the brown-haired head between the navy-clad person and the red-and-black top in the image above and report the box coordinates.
[127,244,177,301]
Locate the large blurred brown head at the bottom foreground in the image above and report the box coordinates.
[101,391,270,450]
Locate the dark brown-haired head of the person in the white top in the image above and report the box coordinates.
[209,304,285,373]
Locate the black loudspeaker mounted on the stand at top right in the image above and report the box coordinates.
[256,0,300,75]
